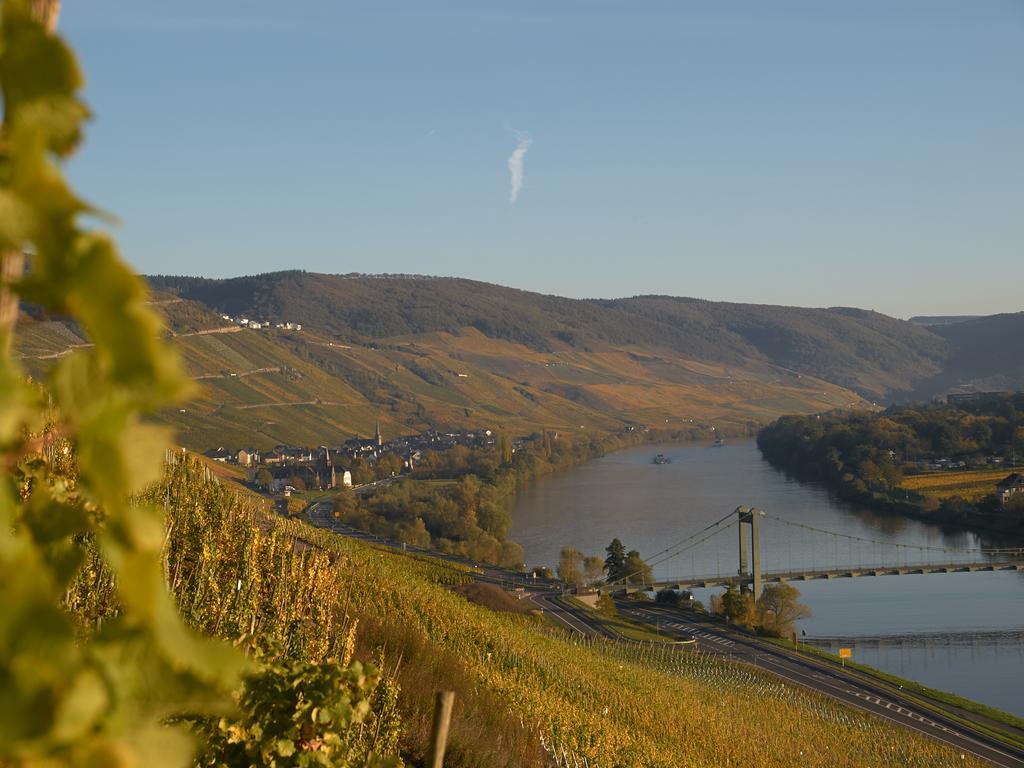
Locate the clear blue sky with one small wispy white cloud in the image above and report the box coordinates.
[60,0,1024,317]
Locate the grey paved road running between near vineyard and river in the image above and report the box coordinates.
[306,502,1024,768]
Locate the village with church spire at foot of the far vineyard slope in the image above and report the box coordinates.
[204,424,507,493]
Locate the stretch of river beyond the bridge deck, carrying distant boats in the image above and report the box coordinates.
[512,440,1019,578]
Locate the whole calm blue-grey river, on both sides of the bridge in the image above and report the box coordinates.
[511,440,1024,717]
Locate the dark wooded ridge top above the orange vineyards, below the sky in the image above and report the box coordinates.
[150,271,951,398]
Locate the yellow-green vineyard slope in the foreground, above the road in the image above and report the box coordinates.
[128,460,976,768]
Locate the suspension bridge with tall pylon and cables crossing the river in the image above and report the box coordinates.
[602,507,1024,599]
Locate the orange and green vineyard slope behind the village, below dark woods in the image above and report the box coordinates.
[20,296,863,450]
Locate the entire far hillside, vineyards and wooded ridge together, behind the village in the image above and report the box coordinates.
[18,271,1024,450]
